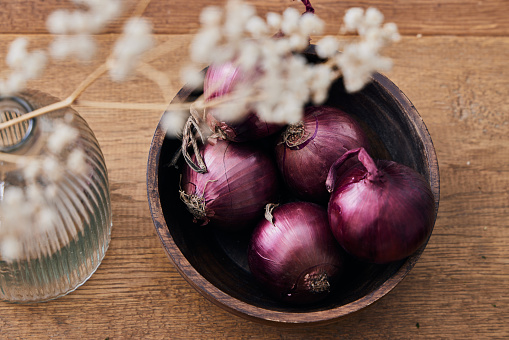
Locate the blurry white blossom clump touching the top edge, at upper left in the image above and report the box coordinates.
[46,0,122,60]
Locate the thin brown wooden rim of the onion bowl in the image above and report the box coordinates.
[146,73,440,325]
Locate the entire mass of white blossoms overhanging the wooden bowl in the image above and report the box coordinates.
[177,0,399,131]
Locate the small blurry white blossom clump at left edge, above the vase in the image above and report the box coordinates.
[0,38,47,96]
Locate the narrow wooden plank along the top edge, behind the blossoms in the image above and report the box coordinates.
[0,0,509,36]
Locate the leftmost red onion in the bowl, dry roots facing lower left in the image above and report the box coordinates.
[181,140,278,231]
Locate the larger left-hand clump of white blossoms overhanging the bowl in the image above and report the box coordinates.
[183,0,331,123]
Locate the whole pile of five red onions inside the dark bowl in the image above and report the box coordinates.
[180,26,435,304]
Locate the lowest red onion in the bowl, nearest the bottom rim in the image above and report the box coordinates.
[248,202,344,304]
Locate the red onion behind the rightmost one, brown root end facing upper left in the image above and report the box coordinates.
[276,106,368,203]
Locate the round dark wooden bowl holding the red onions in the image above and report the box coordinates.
[147,70,439,325]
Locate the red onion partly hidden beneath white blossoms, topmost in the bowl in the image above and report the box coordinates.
[203,62,282,142]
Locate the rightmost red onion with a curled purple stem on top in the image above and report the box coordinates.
[327,148,435,263]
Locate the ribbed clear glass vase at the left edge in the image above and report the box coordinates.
[0,91,112,303]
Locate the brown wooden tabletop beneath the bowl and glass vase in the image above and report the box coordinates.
[0,0,509,339]
